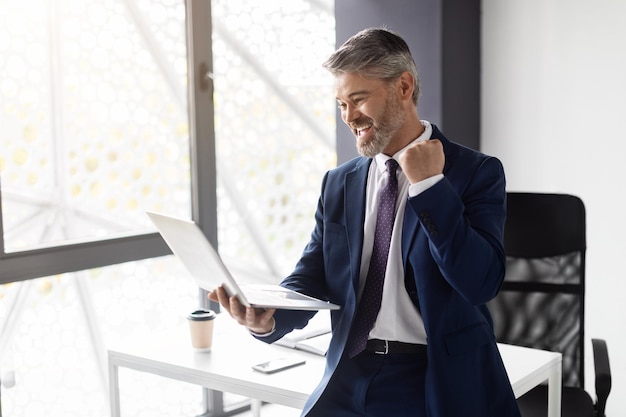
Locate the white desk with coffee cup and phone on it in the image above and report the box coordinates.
[108,317,561,417]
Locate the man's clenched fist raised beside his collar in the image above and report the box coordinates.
[400,139,446,184]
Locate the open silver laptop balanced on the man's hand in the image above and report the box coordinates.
[148,212,340,310]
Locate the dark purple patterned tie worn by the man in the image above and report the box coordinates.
[347,159,398,358]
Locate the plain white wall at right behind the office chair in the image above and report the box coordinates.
[481,0,626,417]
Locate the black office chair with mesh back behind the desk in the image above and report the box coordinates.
[489,193,611,417]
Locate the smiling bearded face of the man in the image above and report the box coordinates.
[336,72,406,158]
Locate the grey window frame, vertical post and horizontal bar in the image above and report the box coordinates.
[0,0,217,285]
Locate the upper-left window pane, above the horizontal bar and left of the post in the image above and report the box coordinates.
[0,0,191,252]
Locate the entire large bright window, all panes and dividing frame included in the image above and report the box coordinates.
[0,0,335,417]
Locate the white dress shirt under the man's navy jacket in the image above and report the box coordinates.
[359,120,443,344]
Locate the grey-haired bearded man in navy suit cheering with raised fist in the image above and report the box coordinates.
[209,28,519,417]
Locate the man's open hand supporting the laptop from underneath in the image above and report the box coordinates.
[208,285,276,334]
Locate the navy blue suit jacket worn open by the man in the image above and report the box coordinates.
[261,126,519,417]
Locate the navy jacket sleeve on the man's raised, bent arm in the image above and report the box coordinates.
[408,157,506,305]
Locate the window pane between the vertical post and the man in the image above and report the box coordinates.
[213,0,336,281]
